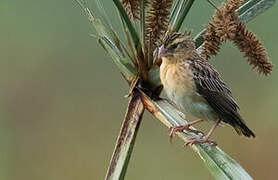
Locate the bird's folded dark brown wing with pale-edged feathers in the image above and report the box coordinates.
[189,60,243,122]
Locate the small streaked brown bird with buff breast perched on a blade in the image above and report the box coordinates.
[158,32,255,145]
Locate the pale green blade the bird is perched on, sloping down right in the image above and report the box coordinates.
[140,91,252,180]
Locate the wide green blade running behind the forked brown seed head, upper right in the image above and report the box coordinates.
[194,0,276,48]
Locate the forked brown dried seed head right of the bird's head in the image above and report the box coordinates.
[202,0,273,75]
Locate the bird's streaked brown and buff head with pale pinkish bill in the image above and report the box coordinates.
[158,33,195,62]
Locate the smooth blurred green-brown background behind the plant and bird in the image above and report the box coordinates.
[0,0,278,180]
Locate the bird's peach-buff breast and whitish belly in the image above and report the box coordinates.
[160,61,218,121]
